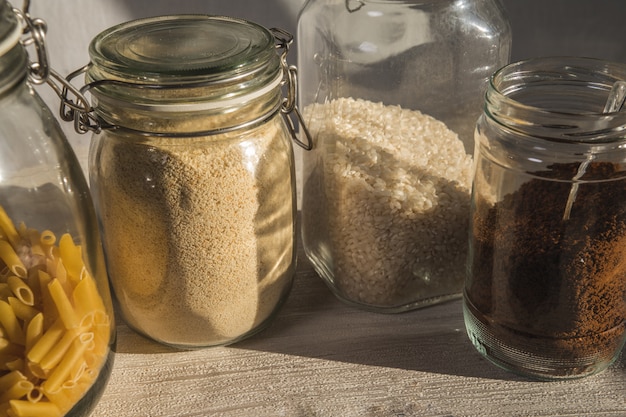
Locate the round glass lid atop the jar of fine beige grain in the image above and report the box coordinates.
[89,15,279,84]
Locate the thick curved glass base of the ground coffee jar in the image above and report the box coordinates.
[463,298,626,380]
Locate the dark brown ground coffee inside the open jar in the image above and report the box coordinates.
[466,163,626,376]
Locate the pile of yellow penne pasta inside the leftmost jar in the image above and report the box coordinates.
[0,207,113,417]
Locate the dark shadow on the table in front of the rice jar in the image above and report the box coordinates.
[232,260,524,380]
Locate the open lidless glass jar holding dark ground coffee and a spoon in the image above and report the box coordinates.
[464,58,626,379]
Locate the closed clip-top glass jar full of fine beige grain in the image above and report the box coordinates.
[72,15,296,348]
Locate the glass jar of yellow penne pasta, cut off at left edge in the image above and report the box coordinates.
[0,0,115,417]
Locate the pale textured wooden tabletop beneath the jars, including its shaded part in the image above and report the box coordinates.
[93,234,626,417]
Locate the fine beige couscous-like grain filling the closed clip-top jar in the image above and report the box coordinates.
[96,118,294,347]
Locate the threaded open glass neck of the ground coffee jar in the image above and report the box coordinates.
[484,57,626,143]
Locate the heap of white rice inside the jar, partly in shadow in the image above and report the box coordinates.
[303,98,472,307]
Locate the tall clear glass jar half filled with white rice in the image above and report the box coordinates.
[298,0,511,313]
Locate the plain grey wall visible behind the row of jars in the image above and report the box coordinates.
[26,0,626,169]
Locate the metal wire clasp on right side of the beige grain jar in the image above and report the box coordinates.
[270,28,313,151]
